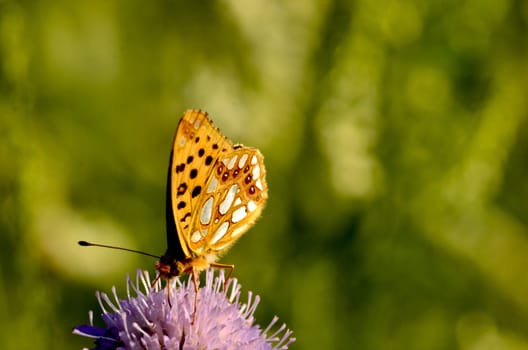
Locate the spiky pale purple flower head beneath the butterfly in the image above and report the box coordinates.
[73,269,295,350]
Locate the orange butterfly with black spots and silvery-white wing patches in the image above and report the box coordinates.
[156,109,268,323]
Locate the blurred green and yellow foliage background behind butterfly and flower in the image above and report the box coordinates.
[0,0,528,350]
